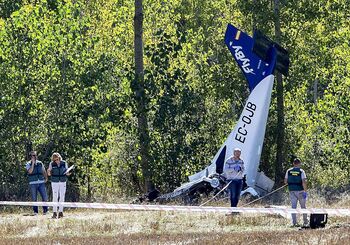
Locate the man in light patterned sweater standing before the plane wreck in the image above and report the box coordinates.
[223,148,244,207]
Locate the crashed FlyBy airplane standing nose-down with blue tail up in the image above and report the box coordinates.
[156,24,289,203]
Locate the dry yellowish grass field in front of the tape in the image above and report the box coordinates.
[0,191,350,245]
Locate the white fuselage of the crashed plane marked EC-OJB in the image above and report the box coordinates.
[189,75,274,188]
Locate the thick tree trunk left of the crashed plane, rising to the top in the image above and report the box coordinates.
[132,0,151,191]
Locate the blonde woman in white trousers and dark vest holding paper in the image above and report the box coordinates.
[47,152,70,219]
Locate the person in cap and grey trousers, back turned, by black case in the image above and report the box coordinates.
[284,158,308,226]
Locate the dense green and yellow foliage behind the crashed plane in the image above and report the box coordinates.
[0,0,350,200]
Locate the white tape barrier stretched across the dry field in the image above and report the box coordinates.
[0,201,350,216]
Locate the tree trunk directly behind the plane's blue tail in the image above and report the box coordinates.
[274,0,285,185]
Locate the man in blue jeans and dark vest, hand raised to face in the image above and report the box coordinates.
[26,151,48,215]
